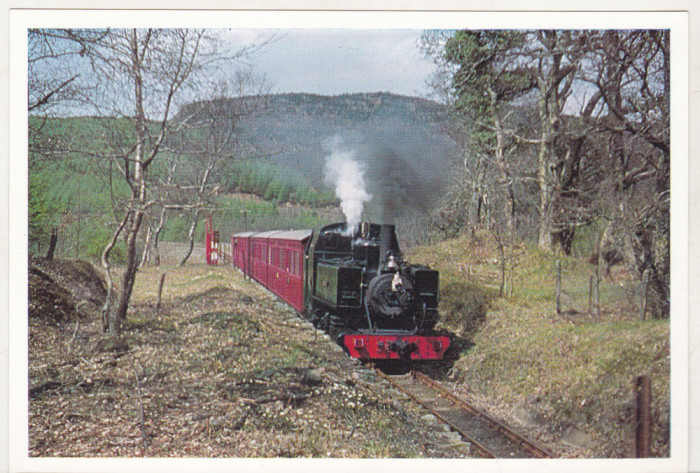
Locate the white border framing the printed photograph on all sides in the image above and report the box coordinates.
[8,10,689,473]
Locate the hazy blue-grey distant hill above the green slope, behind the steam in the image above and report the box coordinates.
[176,93,460,207]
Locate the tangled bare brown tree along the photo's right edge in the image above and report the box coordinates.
[584,30,671,317]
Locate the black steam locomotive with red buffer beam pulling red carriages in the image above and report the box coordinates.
[230,222,450,361]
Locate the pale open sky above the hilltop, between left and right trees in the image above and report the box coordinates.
[223,29,433,97]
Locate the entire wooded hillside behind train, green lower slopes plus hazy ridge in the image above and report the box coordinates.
[29,93,457,259]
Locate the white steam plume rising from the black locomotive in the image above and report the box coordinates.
[325,137,372,235]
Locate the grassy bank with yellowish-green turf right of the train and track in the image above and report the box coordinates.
[409,234,670,457]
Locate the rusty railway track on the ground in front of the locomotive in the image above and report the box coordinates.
[376,370,555,458]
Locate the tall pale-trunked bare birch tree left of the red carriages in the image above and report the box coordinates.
[36,29,270,334]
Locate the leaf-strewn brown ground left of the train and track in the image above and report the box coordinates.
[28,260,468,458]
